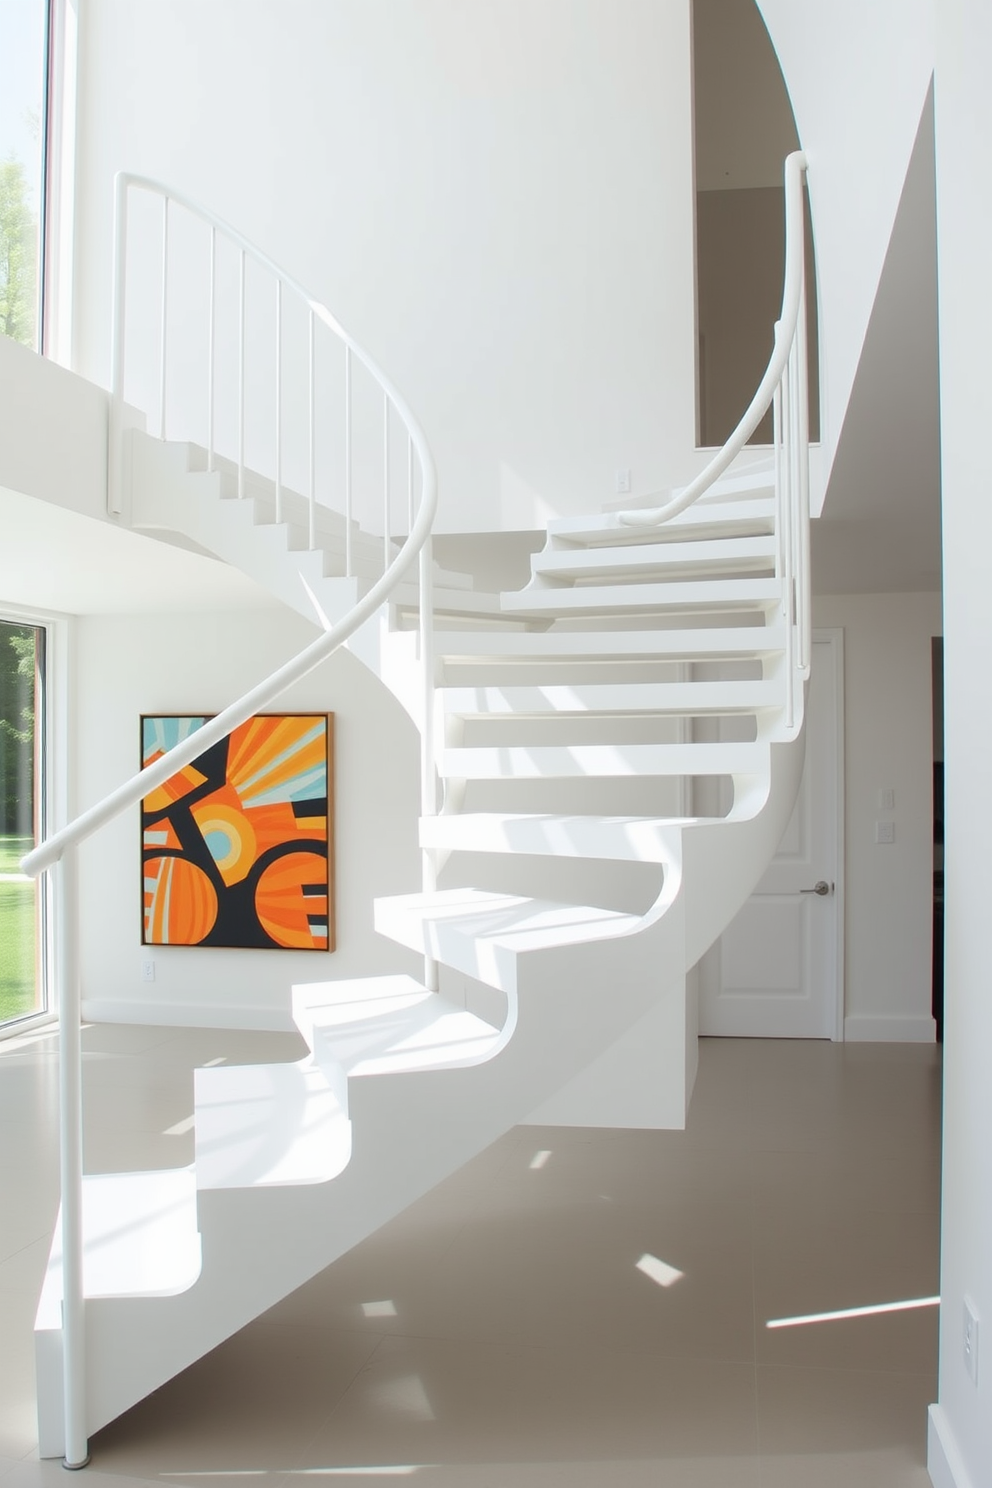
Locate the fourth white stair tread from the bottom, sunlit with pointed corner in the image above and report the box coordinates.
[375,888,641,991]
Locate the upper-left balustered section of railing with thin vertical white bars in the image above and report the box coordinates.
[109,171,424,577]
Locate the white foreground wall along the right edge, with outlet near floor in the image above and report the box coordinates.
[930,0,992,1488]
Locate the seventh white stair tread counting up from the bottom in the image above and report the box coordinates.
[437,679,784,719]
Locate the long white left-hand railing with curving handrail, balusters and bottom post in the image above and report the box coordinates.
[21,174,437,1467]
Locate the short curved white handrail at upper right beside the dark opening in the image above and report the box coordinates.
[617,150,806,527]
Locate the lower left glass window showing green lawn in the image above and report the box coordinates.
[0,620,48,1027]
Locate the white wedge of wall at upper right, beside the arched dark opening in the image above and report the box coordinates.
[757,0,934,485]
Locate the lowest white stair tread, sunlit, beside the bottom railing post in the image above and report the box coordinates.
[37,1168,201,1329]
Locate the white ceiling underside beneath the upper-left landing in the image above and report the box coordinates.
[0,487,278,615]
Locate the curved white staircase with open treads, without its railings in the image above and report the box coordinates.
[29,156,808,1455]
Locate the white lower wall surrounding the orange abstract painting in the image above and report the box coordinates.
[71,612,419,1028]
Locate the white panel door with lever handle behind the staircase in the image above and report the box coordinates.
[699,631,843,1039]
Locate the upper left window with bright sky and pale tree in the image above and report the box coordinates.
[0,0,49,348]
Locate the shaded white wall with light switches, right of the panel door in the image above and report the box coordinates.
[814,594,941,1042]
